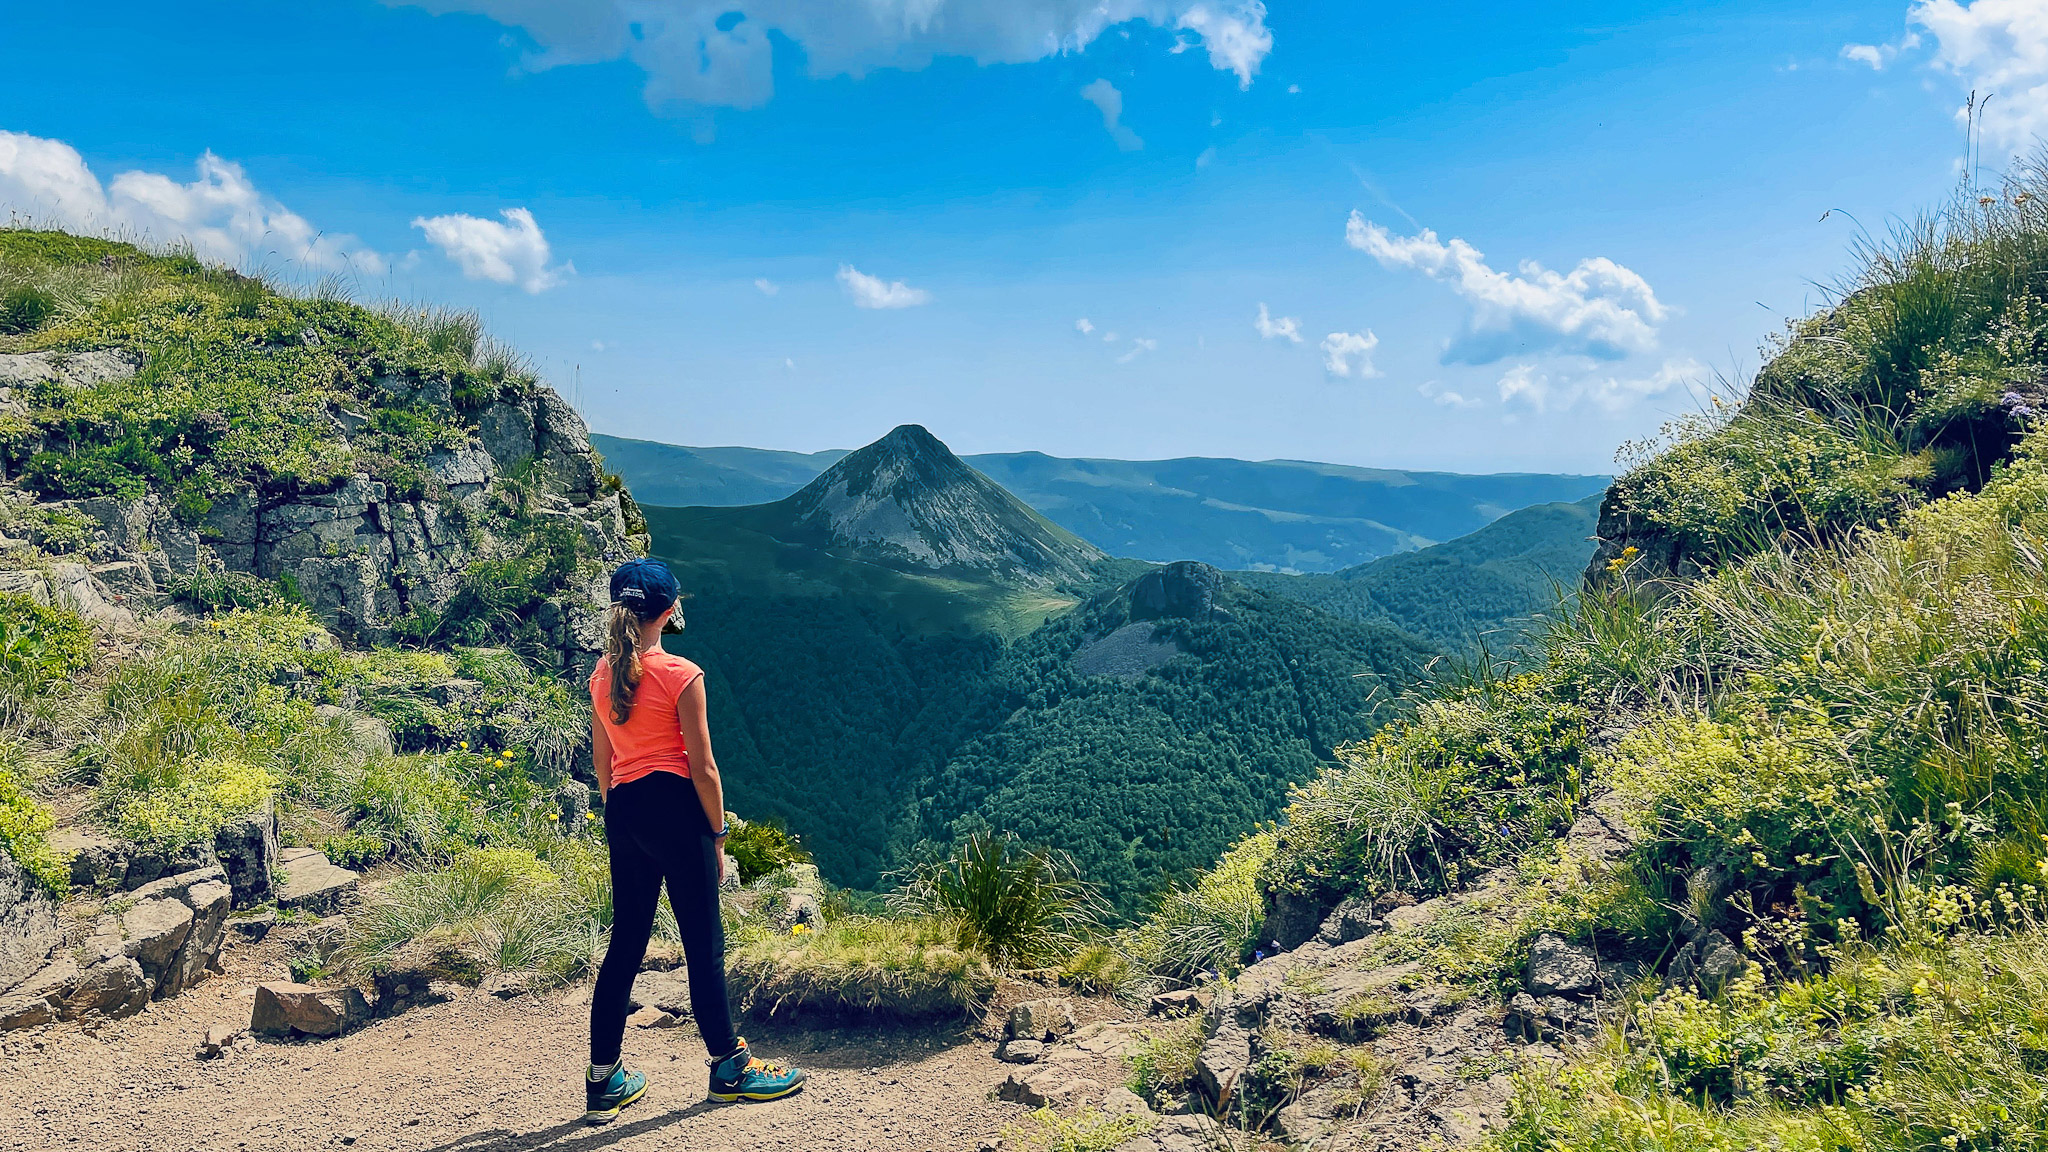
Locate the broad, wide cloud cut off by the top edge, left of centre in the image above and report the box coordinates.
[385,0,1274,109]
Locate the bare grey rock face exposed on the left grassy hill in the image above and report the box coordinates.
[0,351,647,668]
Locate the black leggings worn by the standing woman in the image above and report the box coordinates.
[590,773,739,1068]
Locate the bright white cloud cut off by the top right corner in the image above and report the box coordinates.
[1907,0,2048,152]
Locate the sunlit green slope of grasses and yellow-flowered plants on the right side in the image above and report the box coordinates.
[1105,174,2048,1150]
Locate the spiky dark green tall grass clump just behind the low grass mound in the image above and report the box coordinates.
[891,832,1106,968]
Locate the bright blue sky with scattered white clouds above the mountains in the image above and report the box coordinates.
[0,0,2023,471]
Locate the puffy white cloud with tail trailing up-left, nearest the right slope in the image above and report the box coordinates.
[1343,211,1667,365]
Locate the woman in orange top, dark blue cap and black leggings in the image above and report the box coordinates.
[584,560,805,1123]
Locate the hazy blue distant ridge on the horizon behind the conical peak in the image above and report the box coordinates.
[592,435,1608,572]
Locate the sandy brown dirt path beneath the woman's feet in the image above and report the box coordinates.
[0,949,1122,1152]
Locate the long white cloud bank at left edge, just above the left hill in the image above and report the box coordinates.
[0,131,385,275]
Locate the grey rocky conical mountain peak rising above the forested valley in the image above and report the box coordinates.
[784,424,1104,584]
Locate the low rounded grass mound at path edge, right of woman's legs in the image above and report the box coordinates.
[727,916,995,1019]
